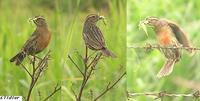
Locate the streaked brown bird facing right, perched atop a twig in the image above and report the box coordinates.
[83,14,116,58]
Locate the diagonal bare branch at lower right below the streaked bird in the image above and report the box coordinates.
[93,72,126,101]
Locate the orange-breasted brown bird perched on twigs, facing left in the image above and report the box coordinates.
[10,16,51,65]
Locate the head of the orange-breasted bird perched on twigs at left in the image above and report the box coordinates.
[29,16,47,27]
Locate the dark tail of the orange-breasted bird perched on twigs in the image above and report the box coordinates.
[10,51,26,65]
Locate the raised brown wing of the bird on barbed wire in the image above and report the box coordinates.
[168,22,190,47]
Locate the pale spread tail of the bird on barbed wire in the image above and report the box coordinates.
[157,59,176,78]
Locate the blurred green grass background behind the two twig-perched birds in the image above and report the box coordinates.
[0,0,126,101]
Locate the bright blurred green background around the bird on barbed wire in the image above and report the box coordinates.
[127,0,200,101]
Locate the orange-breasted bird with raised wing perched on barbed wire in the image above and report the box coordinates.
[143,17,193,78]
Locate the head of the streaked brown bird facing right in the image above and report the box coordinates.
[86,14,105,23]
